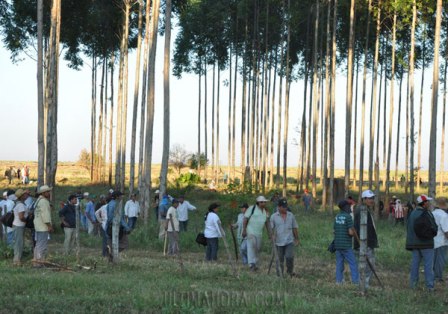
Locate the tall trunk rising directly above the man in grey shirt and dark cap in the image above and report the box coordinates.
[283,0,291,197]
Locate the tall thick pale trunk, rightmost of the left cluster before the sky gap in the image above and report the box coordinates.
[160,0,171,195]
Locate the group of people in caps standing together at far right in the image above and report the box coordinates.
[333,190,448,291]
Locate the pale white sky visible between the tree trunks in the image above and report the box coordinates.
[0,33,440,173]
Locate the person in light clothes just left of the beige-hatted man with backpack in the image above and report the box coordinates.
[12,189,29,265]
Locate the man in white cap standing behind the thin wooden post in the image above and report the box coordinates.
[354,190,378,289]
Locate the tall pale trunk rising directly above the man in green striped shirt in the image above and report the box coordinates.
[345,0,355,195]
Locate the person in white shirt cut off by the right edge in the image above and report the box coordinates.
[432,197,448,282]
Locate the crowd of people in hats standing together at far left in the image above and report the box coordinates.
[0,185,140,266]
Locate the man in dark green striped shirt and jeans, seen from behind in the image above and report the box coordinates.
[333,200,359,284]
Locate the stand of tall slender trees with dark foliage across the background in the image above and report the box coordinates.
[0,0,448,220]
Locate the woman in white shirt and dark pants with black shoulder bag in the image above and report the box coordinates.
[204,203,225,261]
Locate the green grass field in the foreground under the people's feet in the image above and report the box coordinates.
[0,164,448,313]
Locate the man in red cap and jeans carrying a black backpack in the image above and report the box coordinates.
[406,194,437,292]
